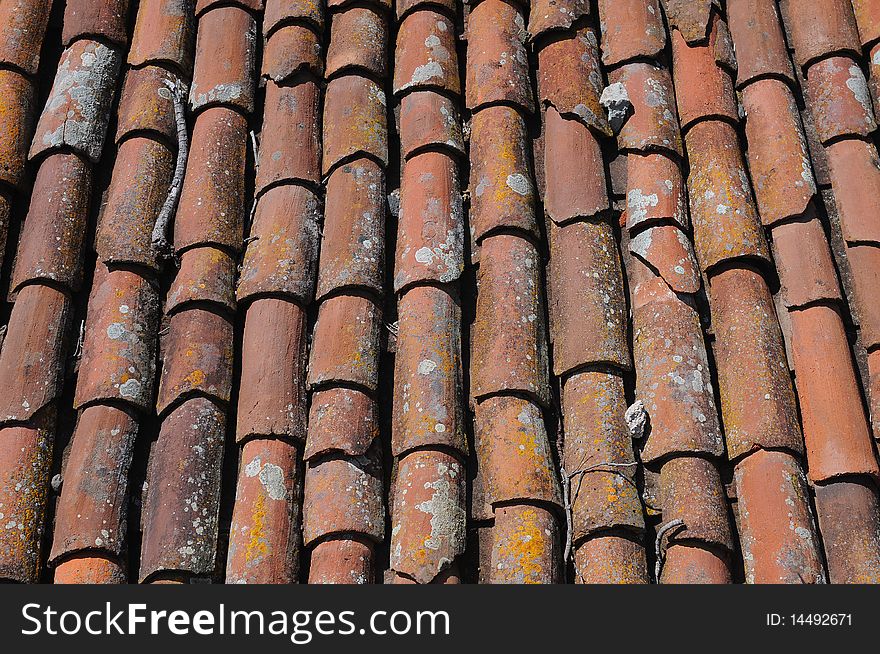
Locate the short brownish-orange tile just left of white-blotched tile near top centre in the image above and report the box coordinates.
[327,6,384,79]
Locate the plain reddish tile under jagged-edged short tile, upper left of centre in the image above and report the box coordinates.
[255,81,321,194]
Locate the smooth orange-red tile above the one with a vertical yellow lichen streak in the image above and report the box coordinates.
[236,298,308,442]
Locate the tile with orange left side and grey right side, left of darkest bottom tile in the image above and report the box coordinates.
[49,398,138,561]
